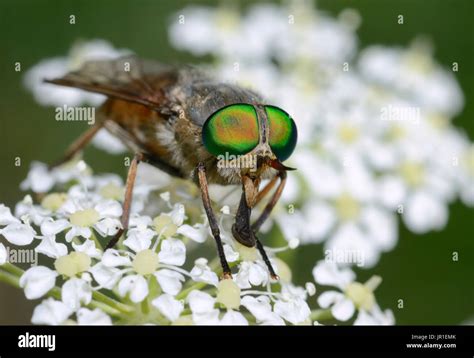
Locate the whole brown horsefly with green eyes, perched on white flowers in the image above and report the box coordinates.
[46,57,297,277]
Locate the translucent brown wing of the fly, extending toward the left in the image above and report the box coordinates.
[45,56,173,112]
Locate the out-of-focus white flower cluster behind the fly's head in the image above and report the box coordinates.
[170,1,474,267]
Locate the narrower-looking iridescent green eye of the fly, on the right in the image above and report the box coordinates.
[265,106,298,161]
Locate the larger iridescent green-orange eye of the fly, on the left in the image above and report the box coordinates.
[202,104,259,156]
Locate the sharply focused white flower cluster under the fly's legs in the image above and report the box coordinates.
[0,160,393,325]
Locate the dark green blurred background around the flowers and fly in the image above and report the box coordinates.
[0,0,474,324]
